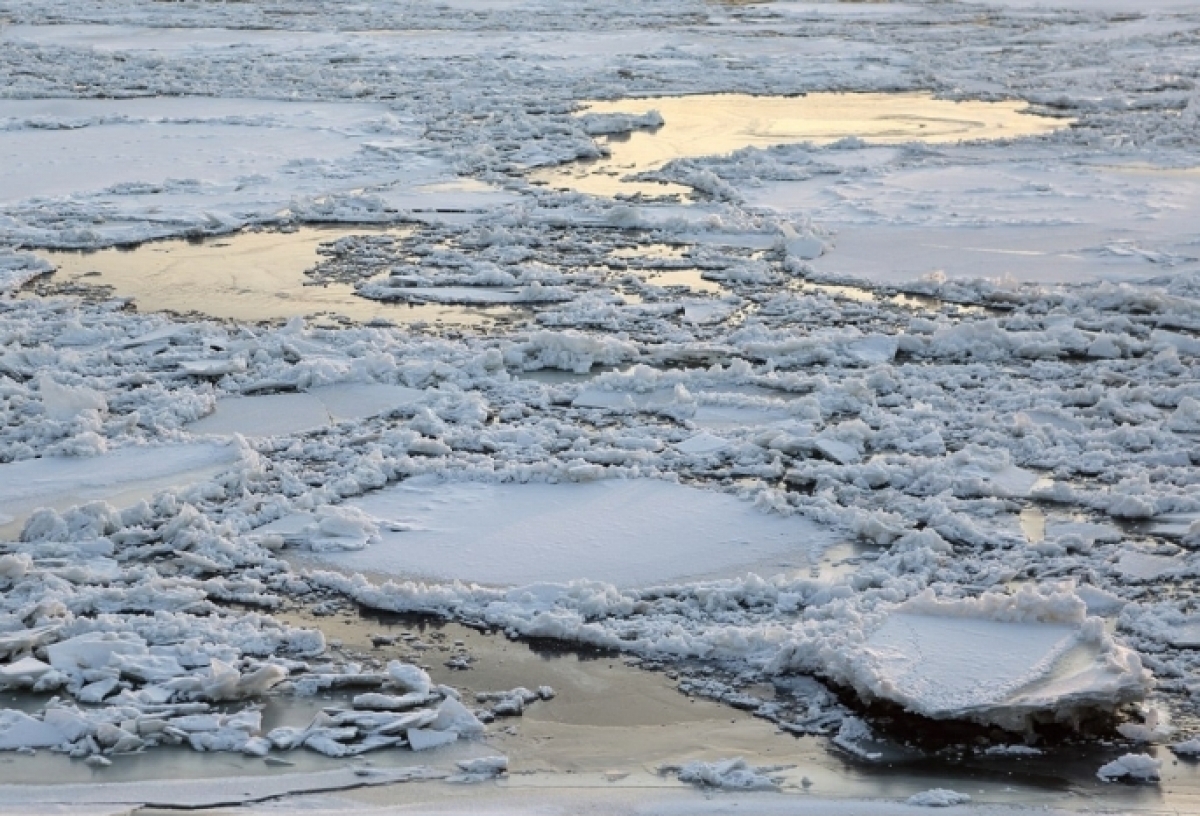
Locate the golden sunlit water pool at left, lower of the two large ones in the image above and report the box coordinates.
[28,226,515,325]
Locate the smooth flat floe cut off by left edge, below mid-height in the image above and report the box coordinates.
[0,444,241,538]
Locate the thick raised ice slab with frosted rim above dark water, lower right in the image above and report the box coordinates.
[826,588,1151,730]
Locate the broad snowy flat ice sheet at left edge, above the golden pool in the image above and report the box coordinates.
[0,96,514,247]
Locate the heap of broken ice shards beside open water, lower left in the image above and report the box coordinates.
[0,636,487,758]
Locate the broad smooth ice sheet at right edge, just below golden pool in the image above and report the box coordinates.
[758,160,1200,283]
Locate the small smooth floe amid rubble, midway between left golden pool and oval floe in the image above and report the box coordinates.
[187,383,425,437]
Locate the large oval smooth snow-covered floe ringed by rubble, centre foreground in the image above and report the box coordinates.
[292,476,836,587]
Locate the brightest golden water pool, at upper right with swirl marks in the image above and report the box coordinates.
[530,94,1069,197]
